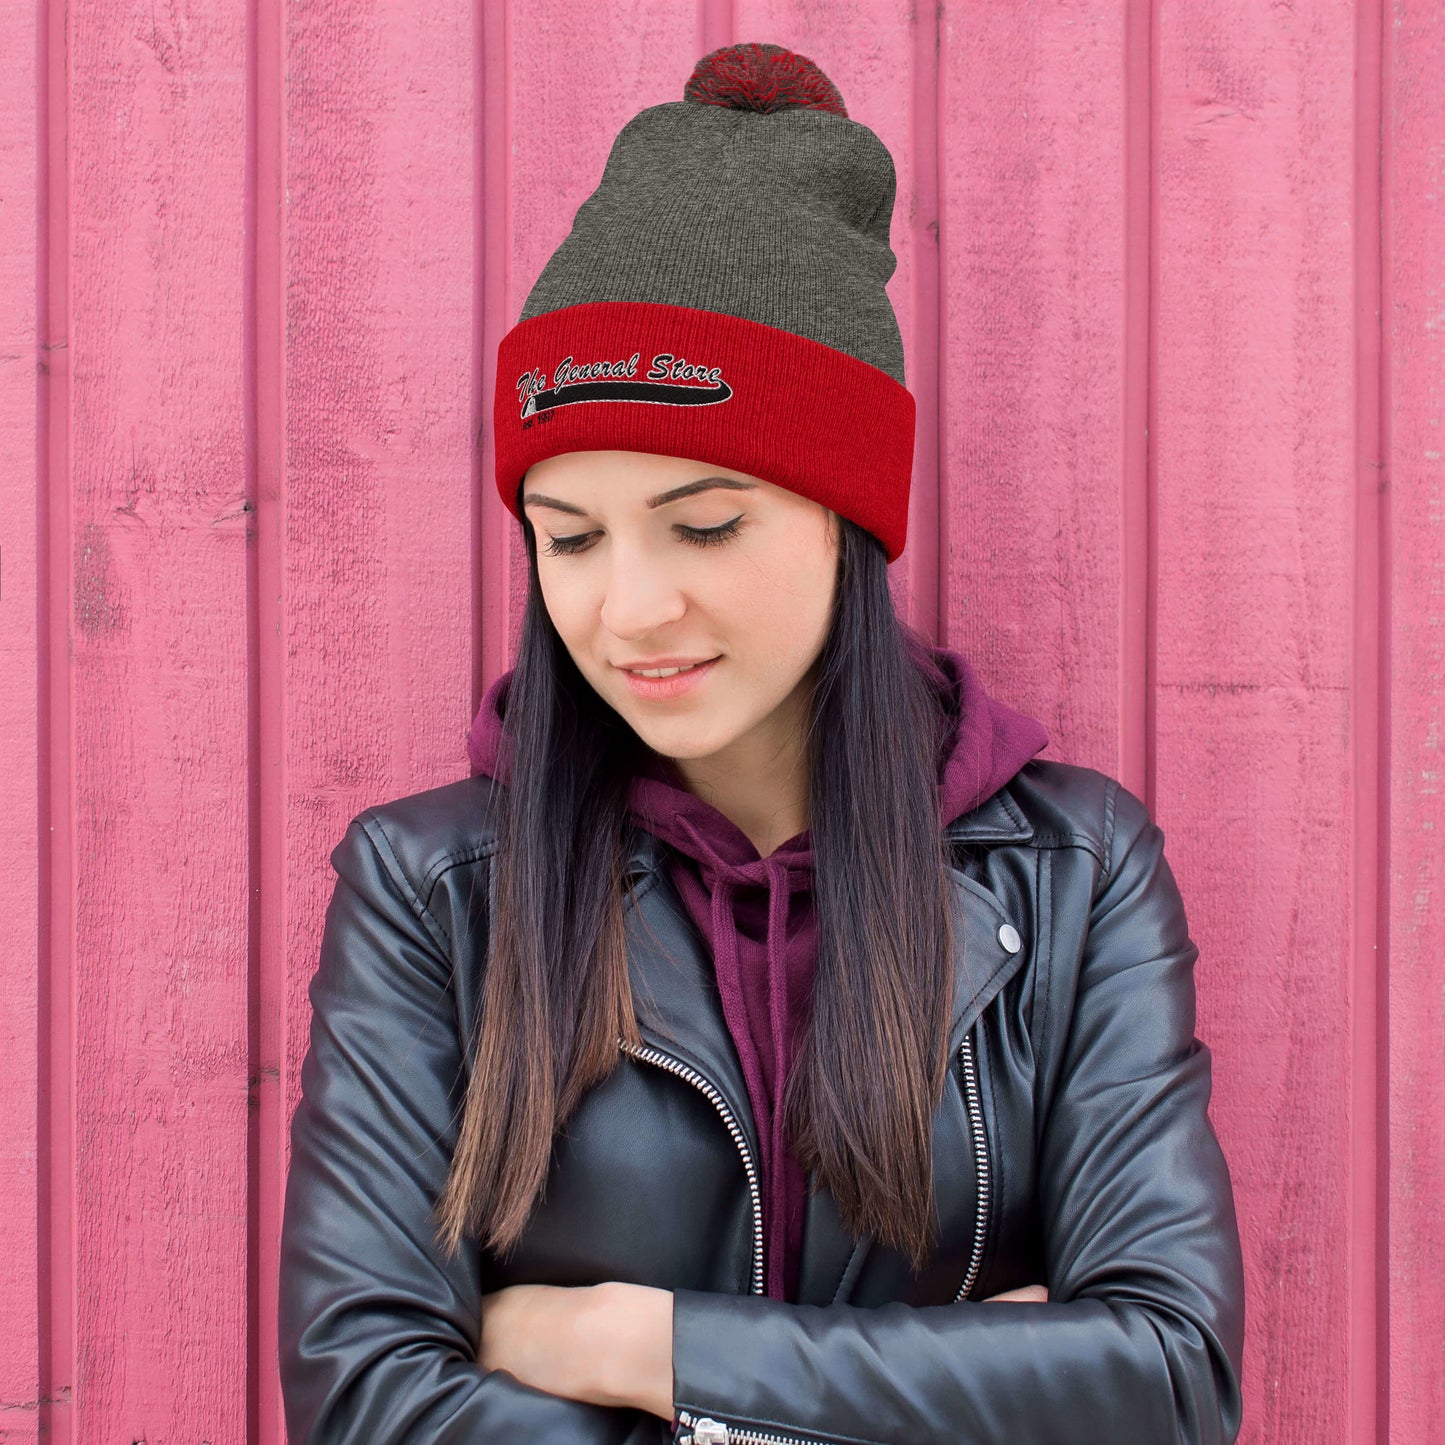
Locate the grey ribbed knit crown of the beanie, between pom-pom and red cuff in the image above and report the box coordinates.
[520,100,906,386]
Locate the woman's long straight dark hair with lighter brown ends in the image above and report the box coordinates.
[436,491,955,1269]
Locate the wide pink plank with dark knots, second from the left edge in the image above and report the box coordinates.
[67,0,247,1441]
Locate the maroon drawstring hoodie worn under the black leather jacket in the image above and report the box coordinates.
[467,642,1049,1301]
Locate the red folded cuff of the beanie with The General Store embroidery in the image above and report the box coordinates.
[493,301,915,562]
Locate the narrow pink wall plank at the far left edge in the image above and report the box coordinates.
[0,3,40,1427]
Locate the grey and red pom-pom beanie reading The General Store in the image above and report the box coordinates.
[493,43,915,562]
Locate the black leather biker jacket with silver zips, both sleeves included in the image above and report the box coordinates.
[279,759,1244,1445]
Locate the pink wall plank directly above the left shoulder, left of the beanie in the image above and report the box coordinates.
[281,0,477,1312]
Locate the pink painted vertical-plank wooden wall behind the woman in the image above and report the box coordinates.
[0,0,1445,1445]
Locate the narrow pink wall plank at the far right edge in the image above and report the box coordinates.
[1381,0,1445,1445]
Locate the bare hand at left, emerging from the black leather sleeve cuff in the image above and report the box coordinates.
[477,1282,672,1420]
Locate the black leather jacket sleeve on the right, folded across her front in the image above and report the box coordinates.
[672,779,1244,1445]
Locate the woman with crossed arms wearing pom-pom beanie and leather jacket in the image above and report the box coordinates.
[280,46,1244,1445]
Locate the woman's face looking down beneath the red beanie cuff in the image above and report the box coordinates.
[522,451,838,766]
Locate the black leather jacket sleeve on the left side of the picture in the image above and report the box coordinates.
[277,814,668,1445]
